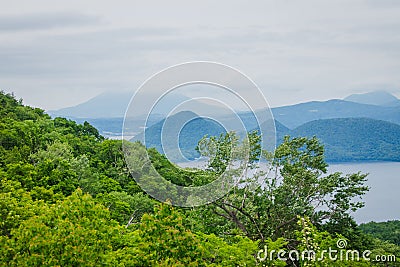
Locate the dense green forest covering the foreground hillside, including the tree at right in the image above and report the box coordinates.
[0,92,400,266]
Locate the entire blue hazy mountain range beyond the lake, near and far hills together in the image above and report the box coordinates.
[49,91,400,161]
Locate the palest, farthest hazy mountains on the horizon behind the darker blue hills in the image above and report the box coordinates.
[47,91,400,125]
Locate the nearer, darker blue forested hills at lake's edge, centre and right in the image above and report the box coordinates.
[132,115,400,162]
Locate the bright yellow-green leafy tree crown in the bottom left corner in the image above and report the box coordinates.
[1,190,121,266]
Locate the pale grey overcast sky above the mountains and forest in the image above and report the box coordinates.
[0,0,400,110]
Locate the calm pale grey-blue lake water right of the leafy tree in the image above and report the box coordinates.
[329,162,400,223]
